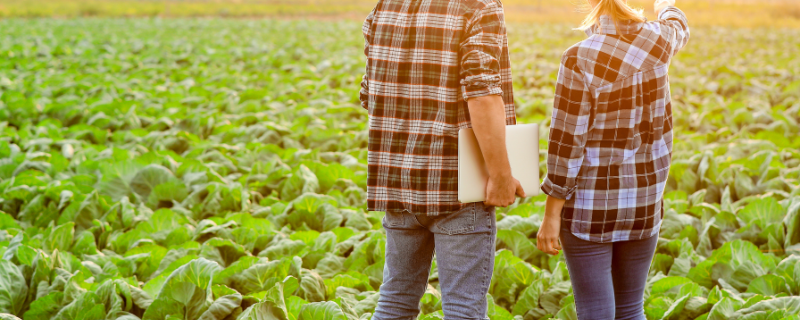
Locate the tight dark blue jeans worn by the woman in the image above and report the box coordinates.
[560,221,658,320]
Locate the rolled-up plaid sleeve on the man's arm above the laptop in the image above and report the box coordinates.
[460,2,506,100]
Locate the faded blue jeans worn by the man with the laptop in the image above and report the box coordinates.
[372,203,497,320]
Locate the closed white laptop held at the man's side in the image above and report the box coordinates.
[458,123,539,203]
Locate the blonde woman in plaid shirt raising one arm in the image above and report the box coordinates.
[537,0,689,320]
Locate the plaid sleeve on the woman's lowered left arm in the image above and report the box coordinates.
[542,49,592,200]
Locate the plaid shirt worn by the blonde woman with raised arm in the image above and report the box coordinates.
[542,7,689,242]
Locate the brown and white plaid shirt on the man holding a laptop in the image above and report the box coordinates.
[360,0,516,216]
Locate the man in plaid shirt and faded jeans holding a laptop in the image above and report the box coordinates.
[360,0,524,320]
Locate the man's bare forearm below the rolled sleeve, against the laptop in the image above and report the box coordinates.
[467,95,511,179]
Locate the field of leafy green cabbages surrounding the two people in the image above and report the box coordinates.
[0,18,800,320]
